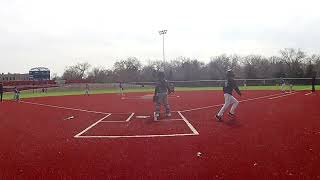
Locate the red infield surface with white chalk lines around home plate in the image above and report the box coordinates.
[0,91,320,180]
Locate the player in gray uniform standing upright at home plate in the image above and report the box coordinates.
[153,72,171,120]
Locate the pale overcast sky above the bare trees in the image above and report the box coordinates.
[0,0,320,75]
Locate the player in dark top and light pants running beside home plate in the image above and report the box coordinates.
[216,70,241,122]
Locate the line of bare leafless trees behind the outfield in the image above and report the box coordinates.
[56,48,320,83]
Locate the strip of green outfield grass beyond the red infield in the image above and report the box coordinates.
[4,86,320,99]
